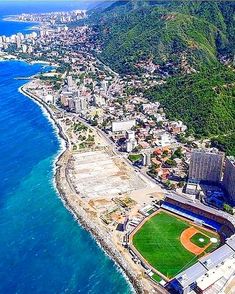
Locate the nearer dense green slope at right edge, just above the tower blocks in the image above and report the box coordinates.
[145,65,235,138]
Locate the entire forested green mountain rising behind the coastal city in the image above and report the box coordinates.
[90,0,235,155]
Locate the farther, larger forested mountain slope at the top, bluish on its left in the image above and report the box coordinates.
[89,0,235,73]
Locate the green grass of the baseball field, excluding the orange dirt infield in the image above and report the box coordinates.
[133,211,219,278]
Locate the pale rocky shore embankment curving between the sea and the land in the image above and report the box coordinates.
[19,82,147,293]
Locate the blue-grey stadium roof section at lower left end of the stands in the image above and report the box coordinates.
[175,262,207,289]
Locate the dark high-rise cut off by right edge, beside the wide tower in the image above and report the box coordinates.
[222,156,235,203]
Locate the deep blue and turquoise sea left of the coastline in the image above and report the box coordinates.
[0,1,131,294]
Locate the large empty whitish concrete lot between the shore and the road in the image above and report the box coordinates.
[68,151,146,199]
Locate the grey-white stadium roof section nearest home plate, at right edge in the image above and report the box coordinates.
[199,244,235,270]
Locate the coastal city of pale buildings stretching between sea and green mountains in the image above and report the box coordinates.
[0,4,235,294]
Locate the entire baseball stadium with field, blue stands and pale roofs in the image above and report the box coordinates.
[128,194,235,294]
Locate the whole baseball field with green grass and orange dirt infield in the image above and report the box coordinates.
[132,211,220,279]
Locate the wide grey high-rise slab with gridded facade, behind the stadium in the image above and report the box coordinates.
[189,150,224,183]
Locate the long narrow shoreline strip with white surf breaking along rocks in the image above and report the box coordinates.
[19,84,141,293]
